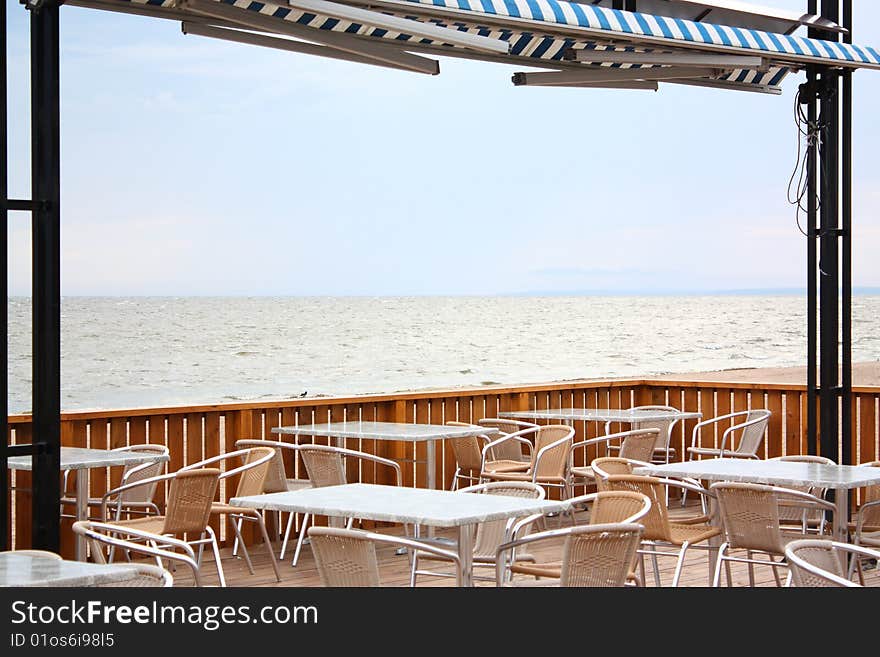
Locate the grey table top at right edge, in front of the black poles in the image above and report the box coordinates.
[633,458,880,489]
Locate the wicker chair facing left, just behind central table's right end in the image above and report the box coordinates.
[480,424,574,499]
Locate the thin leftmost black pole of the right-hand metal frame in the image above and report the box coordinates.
[803,0,819,462]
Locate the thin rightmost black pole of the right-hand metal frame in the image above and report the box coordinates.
[840,0,853,464]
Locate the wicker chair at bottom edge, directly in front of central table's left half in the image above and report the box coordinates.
[308,527,461,587]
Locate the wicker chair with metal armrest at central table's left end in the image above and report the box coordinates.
[181,447,281,582]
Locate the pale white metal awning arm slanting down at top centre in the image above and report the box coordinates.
[279,0,510,55]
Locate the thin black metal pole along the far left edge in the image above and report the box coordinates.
[0,1,10,550]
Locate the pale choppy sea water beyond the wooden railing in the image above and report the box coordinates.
[8,295,880,413]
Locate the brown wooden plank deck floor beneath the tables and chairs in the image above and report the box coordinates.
[175,502,880,588]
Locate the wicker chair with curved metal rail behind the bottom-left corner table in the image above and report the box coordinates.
[73,520,201,586]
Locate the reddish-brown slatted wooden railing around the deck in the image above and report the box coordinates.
[7,379,880,554]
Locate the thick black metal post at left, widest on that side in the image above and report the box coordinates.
[31,0,61,552]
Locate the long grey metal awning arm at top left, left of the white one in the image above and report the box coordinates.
[178,0,437,74]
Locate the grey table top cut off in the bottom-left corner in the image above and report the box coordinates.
[0,551,150,587]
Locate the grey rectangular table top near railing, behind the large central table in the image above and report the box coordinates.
[272,421,499,442]
